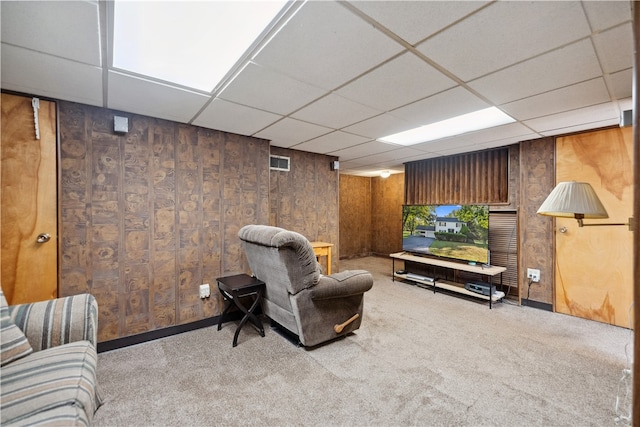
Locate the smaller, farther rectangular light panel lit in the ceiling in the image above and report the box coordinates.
[378,107,515,145]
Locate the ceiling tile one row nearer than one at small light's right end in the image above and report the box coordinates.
[469,39,602,104]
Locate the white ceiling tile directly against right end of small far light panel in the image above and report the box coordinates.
[500,78,609,120]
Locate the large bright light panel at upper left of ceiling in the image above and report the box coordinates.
[113,0,286,92]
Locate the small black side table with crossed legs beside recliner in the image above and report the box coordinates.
[216,274,264,347]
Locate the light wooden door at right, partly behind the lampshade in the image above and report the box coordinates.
[555,127,637,328]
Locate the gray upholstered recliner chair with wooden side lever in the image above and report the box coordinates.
[238,225,373,347]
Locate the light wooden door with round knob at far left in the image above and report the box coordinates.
[0,94,58,304]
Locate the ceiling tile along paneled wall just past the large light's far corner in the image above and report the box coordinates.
[193,98,282,135]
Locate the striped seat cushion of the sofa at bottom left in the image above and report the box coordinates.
[0,341,101,425]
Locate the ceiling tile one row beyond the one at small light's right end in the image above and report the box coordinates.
[525,102,620,135]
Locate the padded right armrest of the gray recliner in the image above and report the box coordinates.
[309,270,373,300]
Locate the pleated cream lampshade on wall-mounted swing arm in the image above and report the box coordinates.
[538,181,609,218]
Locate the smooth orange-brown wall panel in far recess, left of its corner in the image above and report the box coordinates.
[340,175,373,259]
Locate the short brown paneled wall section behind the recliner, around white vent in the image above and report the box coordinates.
[269,147,341,272]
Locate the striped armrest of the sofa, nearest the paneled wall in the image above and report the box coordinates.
[9,294,98,351]
